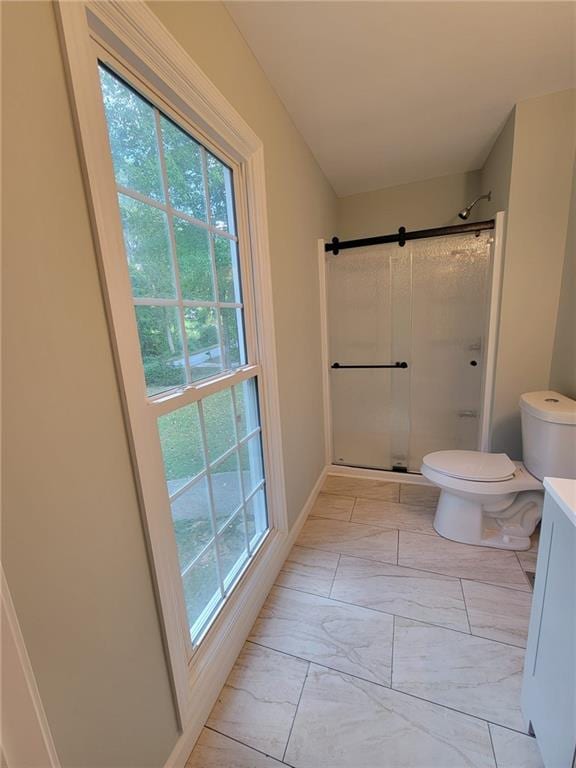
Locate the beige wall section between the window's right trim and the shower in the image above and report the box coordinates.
[150,0,336,521]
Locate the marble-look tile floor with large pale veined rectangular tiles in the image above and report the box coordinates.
[188,476,543,768]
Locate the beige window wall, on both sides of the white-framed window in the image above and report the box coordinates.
[2,2,336,768]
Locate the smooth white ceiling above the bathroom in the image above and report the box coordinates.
[227,0,576,196]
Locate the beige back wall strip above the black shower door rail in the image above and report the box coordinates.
[336,171,480,240]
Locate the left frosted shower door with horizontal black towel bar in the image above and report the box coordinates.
[327,245,410,469]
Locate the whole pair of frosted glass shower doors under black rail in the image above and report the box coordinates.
[326,230,493,472]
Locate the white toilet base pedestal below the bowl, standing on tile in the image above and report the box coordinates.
[434,489,544,551]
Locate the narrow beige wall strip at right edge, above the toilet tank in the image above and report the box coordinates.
[550,155,576,399]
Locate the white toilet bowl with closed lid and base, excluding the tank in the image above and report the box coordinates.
[422,451,544,550]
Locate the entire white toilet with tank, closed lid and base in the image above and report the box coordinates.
[421,391,576,550]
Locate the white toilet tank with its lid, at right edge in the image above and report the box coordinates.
[520,391,576,480]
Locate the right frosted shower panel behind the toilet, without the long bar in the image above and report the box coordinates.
[410,232,491,472]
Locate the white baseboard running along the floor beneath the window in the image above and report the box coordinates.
[164,467,327,768]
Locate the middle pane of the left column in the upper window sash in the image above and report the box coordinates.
[118,194,176,299]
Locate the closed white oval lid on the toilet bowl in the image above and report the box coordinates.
[423,451,516,482]
